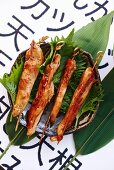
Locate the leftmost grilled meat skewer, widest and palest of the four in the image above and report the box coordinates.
[12,40,44,117]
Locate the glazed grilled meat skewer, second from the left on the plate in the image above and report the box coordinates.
[27,54,61,136]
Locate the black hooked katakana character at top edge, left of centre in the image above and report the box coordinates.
[21,0,50,20]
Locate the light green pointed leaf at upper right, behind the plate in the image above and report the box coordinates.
[72,11,114,61]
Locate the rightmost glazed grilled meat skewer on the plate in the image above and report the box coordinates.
[50,67,95,142]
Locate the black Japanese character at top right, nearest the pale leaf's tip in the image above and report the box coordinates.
[85,0,109,21]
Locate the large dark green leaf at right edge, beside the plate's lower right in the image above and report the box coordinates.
[74,69,114,155]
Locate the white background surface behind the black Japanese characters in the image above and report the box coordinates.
[0,0,114,170]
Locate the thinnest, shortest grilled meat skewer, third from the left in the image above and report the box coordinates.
[49,59,76,124]
